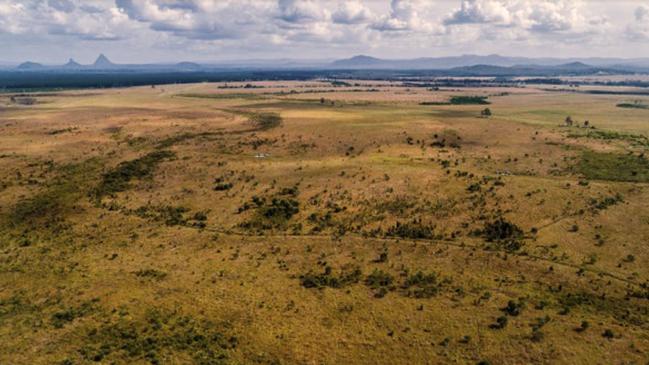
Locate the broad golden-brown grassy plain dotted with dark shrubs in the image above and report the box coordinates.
[0,81,649,365]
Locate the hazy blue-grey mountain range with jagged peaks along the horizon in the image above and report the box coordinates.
[7,54,649,76]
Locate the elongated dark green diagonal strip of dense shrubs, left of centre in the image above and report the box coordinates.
[94,151,175,199]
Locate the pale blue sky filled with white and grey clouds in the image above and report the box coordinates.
[0,0,649,63]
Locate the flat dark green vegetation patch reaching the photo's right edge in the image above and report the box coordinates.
[575,151,649,182]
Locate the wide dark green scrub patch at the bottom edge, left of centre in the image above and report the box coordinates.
[78,311,238,365]
